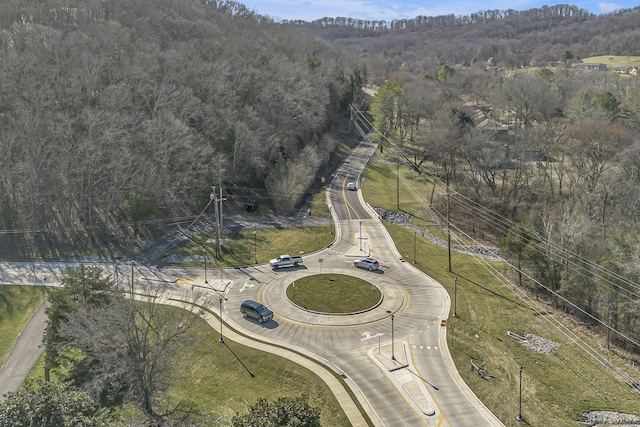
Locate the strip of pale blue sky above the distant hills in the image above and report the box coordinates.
[238,0,639,21]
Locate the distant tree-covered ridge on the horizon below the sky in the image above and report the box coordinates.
[296,4,640,70]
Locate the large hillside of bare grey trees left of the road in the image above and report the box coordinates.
[0,0,358,256]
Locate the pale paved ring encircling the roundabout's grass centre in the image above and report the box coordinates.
[261,269,408,327]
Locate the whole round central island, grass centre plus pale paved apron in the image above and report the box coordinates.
[261,269,408,327]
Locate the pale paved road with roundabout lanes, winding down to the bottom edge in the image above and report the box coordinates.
[0,142,503,427]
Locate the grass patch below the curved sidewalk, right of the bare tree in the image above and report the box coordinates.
[165,312,349,427]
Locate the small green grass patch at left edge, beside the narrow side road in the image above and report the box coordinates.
[0,285,47,366]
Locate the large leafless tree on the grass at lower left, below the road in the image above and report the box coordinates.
[62,291,197,425]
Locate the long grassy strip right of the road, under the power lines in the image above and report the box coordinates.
[363,154,640,426]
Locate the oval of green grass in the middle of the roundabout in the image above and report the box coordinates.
[287,274,382,314]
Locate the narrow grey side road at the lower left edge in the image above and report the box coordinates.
[0,300,49,400]
